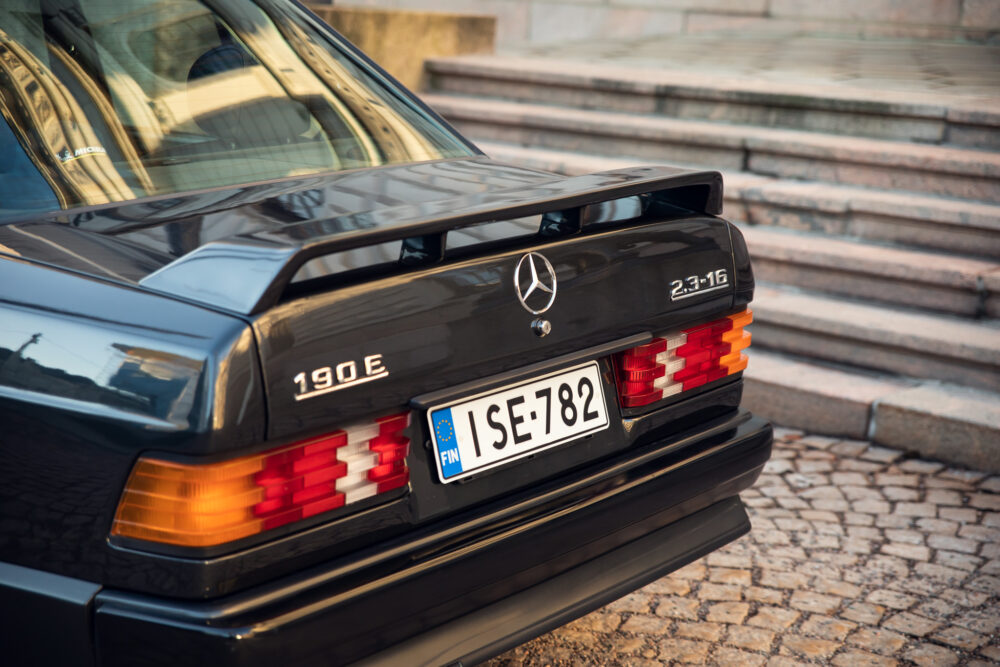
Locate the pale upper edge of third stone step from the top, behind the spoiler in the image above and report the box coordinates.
[477,141,1000,234]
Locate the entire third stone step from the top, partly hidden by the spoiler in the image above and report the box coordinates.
[478,141,1000,260]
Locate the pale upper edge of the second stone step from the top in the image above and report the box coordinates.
[422,94,1000,179]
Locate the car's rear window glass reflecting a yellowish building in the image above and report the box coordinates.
[0,0,471,219]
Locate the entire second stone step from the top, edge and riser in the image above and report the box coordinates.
[424,94,1000,203]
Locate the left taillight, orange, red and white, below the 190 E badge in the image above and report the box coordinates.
[111,413,410,547]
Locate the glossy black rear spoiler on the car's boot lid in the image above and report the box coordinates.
[139,167,722,315]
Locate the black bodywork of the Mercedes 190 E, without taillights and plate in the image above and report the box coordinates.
[0,0,771,667]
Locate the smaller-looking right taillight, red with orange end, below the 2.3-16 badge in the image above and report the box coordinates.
[615,310,753,408]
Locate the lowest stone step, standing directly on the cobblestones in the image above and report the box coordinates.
[743,350,1000,472]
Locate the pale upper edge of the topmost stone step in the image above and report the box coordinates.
[425,56,1000,127]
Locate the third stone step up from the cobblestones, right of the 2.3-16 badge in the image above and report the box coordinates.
[743,225,1000,317]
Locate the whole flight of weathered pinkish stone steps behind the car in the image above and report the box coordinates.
[424,49,1000,471]
